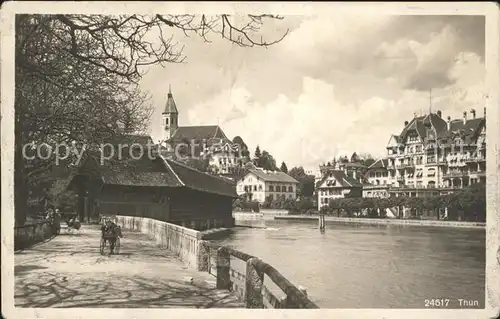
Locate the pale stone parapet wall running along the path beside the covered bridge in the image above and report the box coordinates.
[116,216,205,270]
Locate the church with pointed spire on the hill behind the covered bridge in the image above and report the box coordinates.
[160,88,241,175]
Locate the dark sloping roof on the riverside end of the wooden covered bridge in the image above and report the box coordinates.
[165,159,238,198]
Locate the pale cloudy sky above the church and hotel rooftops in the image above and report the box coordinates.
[141,12,486,170]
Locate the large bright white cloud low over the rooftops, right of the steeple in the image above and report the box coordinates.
[189,77,416,167]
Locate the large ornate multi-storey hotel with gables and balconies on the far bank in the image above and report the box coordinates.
[317,109,486,208]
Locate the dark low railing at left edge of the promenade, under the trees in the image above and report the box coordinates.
[14,221,57,251]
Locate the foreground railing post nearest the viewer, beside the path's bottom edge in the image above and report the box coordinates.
[245,258,264,309]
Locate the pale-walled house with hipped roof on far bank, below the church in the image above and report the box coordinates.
[236,168,299,203]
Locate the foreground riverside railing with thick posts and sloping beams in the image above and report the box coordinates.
[201,241,319,309]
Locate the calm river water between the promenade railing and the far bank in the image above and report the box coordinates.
[214,220,486,308]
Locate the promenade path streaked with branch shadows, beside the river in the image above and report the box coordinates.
[14,225,244,308]
